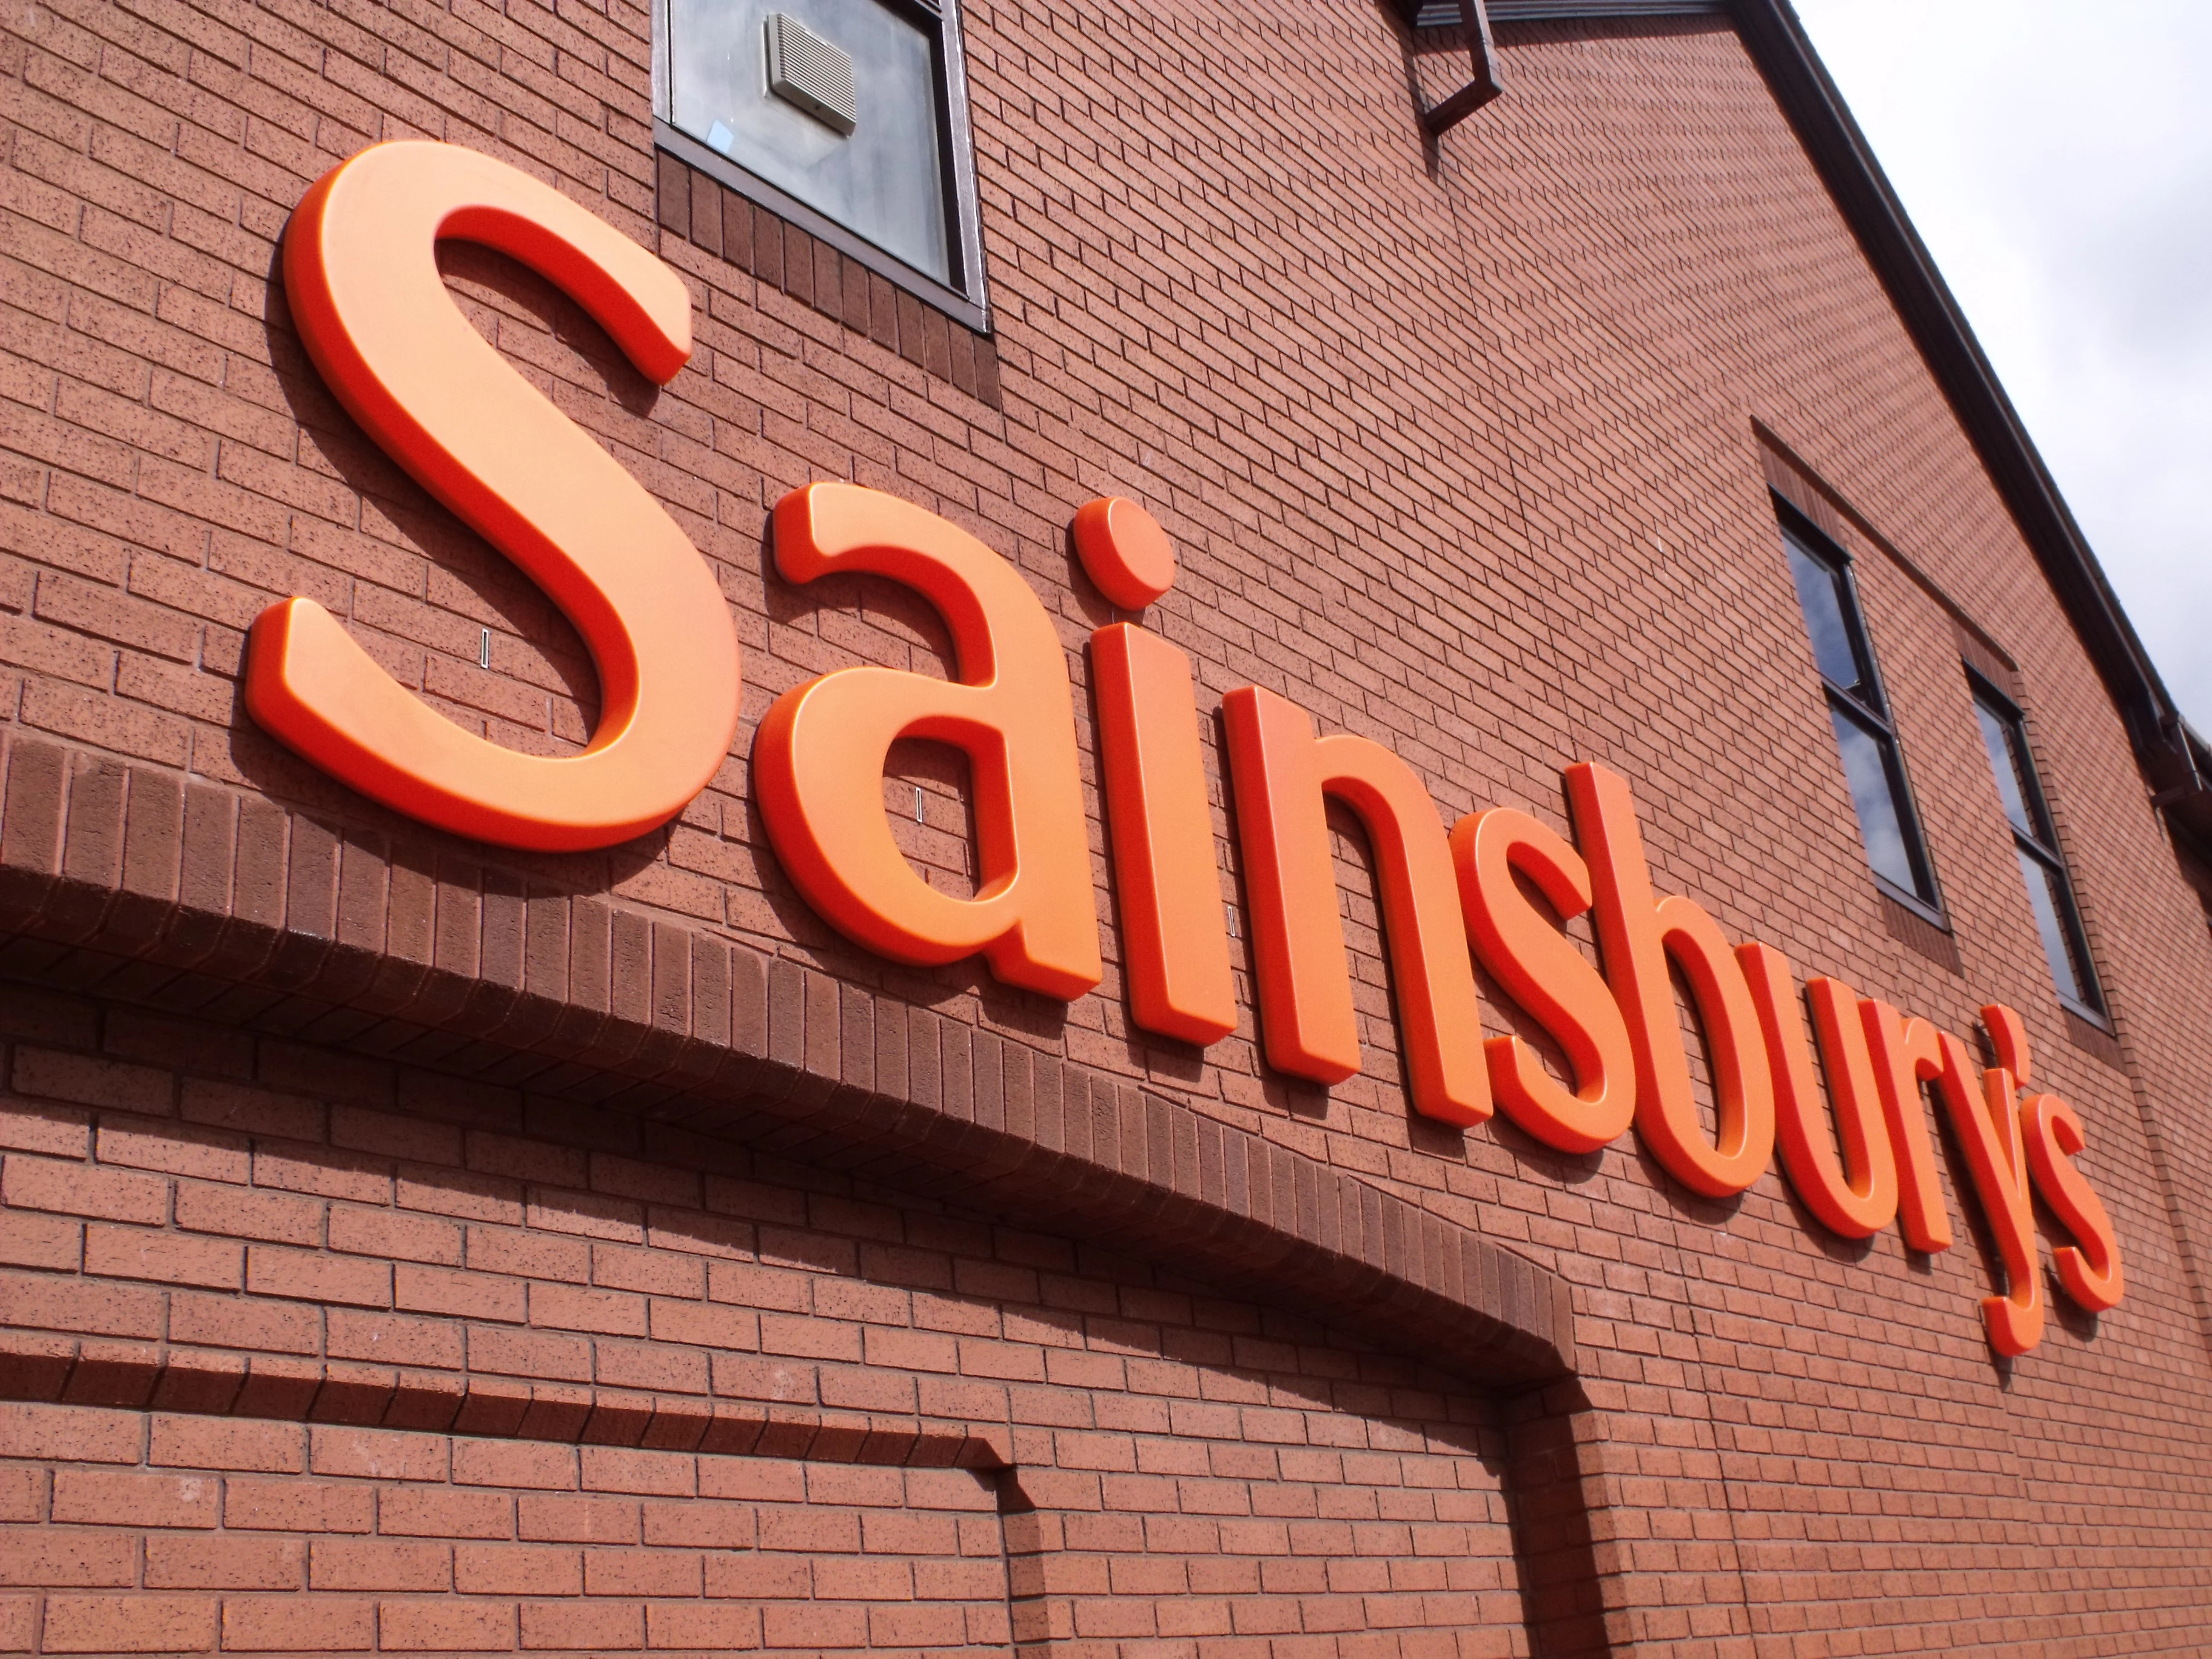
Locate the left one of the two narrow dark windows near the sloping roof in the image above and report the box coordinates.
[1783,515,1942,925]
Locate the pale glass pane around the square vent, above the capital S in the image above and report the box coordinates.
[668,0,951,283]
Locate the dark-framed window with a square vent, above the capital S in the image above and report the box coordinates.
[652,0,987,327]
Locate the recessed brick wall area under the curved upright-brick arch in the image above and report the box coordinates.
[0,993,1526,1659]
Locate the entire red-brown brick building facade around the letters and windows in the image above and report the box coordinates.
[0,0,2212,1659]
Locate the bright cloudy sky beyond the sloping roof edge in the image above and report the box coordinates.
[1796,0,2212,734]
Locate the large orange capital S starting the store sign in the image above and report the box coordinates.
[246,141,739,851]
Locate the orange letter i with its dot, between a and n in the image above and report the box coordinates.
[1075,498,1236,1047]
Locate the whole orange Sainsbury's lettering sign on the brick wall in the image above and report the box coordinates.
[246,144,2123,1354]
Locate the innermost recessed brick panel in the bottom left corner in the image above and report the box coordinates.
[0,1407,1013,1655]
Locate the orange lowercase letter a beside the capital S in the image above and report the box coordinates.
[752,484,1102,1002]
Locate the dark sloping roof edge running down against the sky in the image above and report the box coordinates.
[1730,0,2212,840]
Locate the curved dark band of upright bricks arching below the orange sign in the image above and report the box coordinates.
[0,734,1575,1387]
